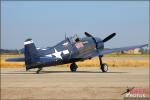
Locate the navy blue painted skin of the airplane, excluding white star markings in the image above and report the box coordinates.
[6,33,148,69]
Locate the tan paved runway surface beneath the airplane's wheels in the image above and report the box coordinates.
[1,67,149,99]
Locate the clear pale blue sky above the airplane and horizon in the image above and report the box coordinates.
[1,1,149,49]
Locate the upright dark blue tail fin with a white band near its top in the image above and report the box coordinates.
[24,39,39,70]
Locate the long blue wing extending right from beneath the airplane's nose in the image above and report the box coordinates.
[100,44,148,55]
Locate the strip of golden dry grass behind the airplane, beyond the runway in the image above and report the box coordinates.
[1,55,149,68]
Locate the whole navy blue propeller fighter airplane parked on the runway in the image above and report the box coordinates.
[6,32,148,74]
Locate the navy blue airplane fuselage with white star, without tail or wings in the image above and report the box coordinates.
[29,37,104,67]
